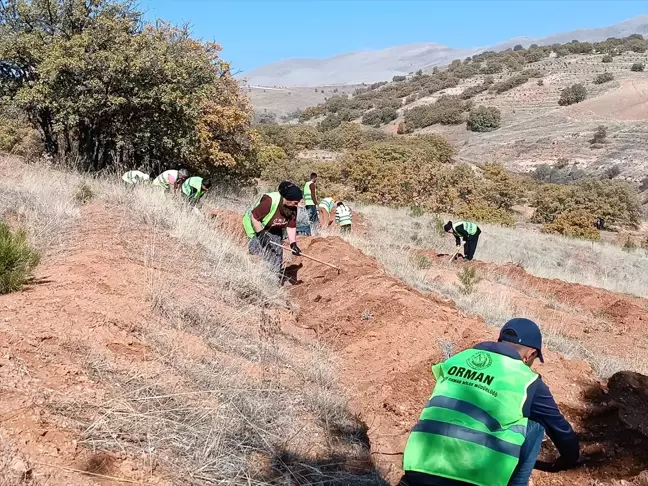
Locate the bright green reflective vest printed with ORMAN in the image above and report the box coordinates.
[403,349,538,486]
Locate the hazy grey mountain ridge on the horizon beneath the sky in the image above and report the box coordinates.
[242,14,648,87]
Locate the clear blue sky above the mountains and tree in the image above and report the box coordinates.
[140,0,648,71]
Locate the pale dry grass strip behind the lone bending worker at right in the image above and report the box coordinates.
[356,206,648,297]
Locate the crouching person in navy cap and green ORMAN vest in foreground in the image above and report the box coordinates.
[401,318,580,486]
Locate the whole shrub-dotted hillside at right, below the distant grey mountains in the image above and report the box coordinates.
[248,34,648,182]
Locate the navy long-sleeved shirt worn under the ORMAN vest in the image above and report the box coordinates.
[402,342,580,486]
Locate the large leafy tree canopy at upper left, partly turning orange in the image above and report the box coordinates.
[0,0,255,176]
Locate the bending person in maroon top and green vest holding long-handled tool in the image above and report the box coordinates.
[243,181,303,275]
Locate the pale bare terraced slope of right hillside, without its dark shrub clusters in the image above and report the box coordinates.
[410,53,648,180]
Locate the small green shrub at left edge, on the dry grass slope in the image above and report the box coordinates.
[0,221,40,294]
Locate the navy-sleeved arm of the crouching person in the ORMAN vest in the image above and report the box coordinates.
[525,378,580,467]
